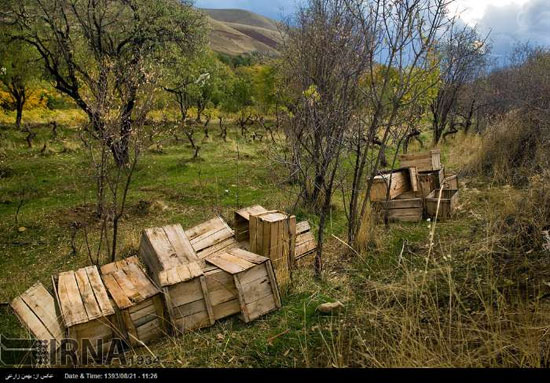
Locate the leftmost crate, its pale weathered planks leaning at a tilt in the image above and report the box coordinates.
[10,282,65,352]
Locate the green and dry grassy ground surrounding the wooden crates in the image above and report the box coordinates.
[0,109,550,367]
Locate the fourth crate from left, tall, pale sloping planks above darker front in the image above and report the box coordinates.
[140,225,214,332]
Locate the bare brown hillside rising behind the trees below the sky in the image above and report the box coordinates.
[202,9,281,55]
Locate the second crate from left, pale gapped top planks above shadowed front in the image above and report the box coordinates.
[54,266,119,352]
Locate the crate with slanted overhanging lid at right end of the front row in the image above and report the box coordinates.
[207,249,281,323]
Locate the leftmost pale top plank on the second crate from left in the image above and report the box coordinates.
[58,271,88,327]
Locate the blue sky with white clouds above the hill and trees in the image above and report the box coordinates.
[196,0,550,60]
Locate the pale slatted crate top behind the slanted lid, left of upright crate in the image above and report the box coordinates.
[185,217,238,260]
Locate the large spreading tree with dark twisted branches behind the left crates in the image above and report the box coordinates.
[1,0,206,262]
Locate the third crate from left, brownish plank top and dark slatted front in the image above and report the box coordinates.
[101,257,166,346]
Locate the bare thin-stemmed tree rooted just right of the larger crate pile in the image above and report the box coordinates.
[284,0,366,275]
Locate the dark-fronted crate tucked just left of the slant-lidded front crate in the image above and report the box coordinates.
[204,265,241,320]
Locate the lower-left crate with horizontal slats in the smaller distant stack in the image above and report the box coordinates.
[373,192,424,222]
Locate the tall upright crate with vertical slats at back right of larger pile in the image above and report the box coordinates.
[249,211,296,286]
